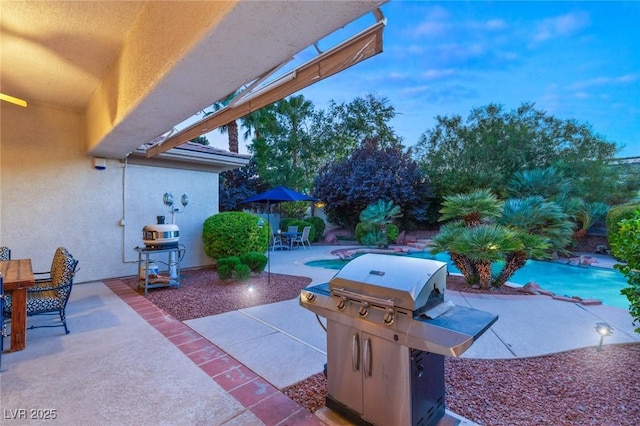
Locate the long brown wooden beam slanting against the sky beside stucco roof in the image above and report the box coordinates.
[147,18,386,158]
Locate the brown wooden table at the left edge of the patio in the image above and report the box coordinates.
[0,259,35,352]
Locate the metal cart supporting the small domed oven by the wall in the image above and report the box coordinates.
[134,244,185,296]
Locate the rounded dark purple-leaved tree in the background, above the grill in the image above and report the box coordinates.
[313,139,431,229]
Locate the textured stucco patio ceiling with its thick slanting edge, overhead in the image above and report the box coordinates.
[0,0,384,158]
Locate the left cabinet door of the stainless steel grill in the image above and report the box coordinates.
[327,321,362,414]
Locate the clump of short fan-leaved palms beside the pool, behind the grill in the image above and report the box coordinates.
[430,190,573,289]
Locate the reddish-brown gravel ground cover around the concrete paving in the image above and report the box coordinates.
[123,268,640,426]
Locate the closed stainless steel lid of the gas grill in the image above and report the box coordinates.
[329,253,447,312]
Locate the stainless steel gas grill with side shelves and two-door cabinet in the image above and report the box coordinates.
[300,254,498,426]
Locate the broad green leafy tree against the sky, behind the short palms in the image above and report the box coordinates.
[414,103,617,201]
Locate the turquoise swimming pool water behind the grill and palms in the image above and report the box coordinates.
[305,251,629,309]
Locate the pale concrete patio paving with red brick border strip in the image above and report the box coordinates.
[0,246,640,425]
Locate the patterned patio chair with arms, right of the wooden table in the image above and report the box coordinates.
[3,247,78,334]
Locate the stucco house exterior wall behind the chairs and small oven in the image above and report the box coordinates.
[0,102,218,283]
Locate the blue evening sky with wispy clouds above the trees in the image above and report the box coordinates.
[208,0,640,157]
